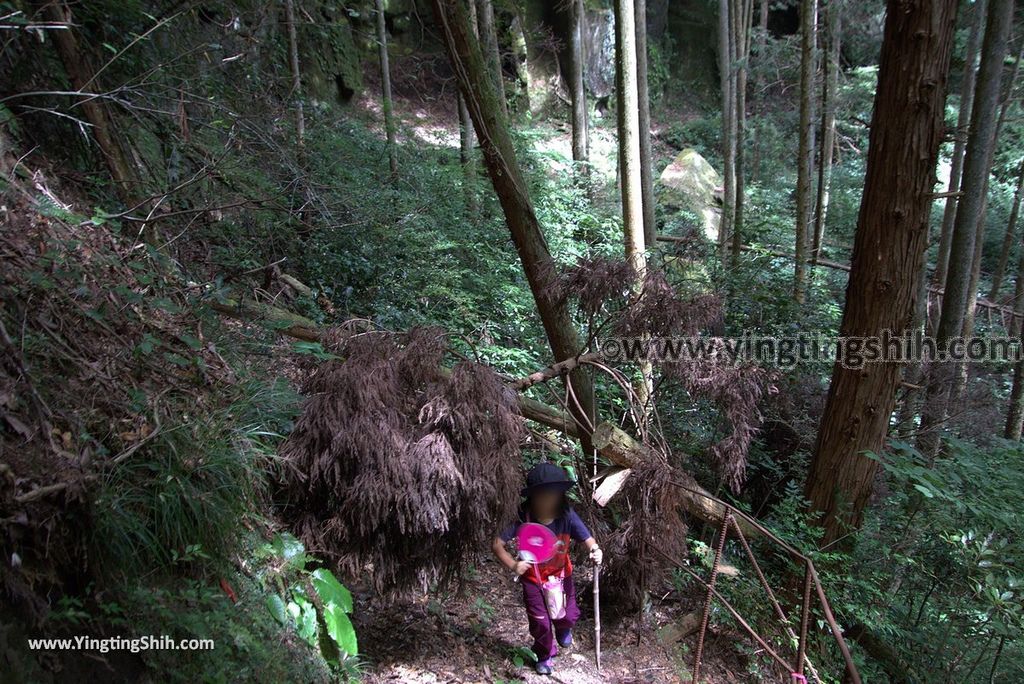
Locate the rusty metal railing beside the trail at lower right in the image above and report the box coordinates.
[654,480,860,684]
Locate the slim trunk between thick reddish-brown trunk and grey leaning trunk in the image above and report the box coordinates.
[929,0,988,305]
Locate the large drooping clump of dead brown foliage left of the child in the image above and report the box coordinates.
[281,328,523,595]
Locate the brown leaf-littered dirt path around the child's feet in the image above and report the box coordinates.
[354,558,749,684]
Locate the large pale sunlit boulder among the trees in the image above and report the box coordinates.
[658,147,722,241]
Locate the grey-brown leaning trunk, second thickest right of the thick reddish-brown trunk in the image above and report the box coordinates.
[916,0,1014,459]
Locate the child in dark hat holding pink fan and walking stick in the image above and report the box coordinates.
[492,463,602,675]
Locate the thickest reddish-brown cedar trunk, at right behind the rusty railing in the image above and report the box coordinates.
[805,0,956,545]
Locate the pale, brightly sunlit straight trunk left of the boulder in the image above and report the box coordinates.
[615,0,651,413]
